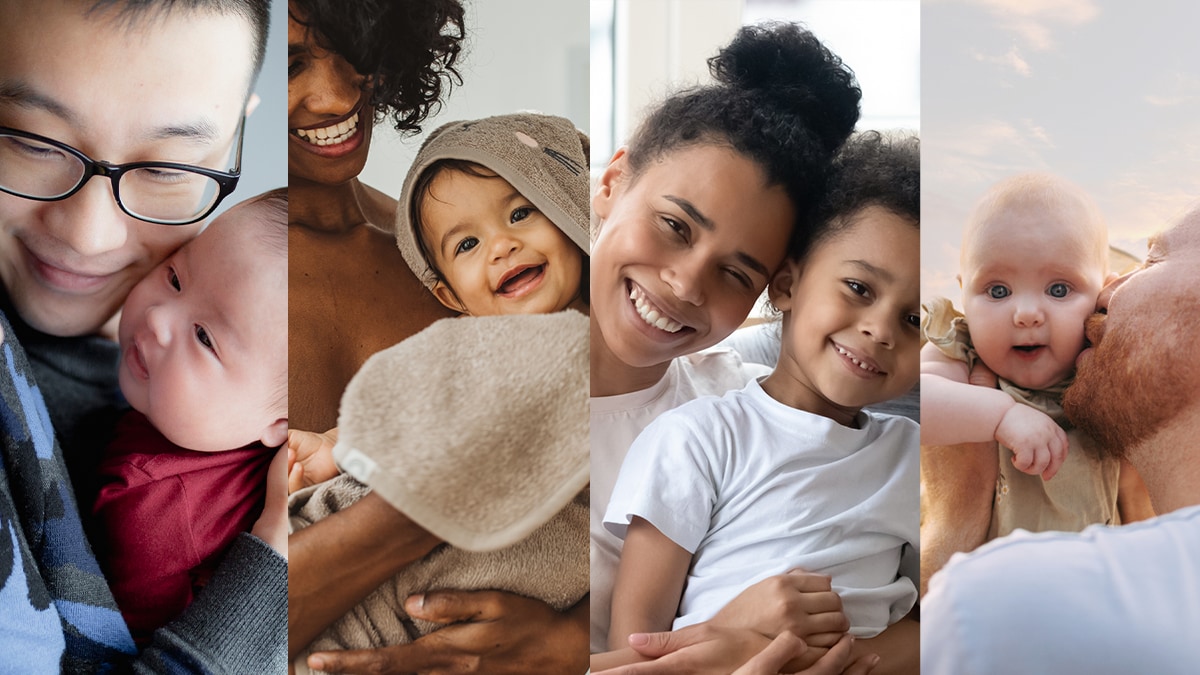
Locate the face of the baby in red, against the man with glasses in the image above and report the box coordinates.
[119,201,288,452]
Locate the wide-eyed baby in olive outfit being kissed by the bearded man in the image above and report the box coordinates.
[922,173,1120,585]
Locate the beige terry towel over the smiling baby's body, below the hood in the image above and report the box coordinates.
[289,311,589,674]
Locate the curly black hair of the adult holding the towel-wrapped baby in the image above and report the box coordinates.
[289,0,466,135]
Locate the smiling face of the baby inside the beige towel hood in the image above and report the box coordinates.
[421,169,583,316]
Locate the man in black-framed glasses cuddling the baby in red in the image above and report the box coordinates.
[0,0,287,673]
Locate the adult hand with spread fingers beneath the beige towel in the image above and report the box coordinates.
[308,591,588,675]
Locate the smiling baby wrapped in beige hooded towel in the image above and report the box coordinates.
[289,114,589,673]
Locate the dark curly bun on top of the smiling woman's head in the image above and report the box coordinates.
[708,22,863,153]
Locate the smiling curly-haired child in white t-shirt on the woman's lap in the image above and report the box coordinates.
[605,133,920,650]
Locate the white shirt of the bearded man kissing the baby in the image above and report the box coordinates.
[920,506,1200,675]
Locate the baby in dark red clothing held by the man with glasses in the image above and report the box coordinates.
[94,189,288,645]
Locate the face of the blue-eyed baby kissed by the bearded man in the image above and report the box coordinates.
[960,201,1106,389]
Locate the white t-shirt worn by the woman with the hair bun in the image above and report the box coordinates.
[590,350,770,652]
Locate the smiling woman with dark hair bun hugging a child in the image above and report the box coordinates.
[592,23,912,673]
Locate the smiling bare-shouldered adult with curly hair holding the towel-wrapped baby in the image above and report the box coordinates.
[288,0,589,673]
